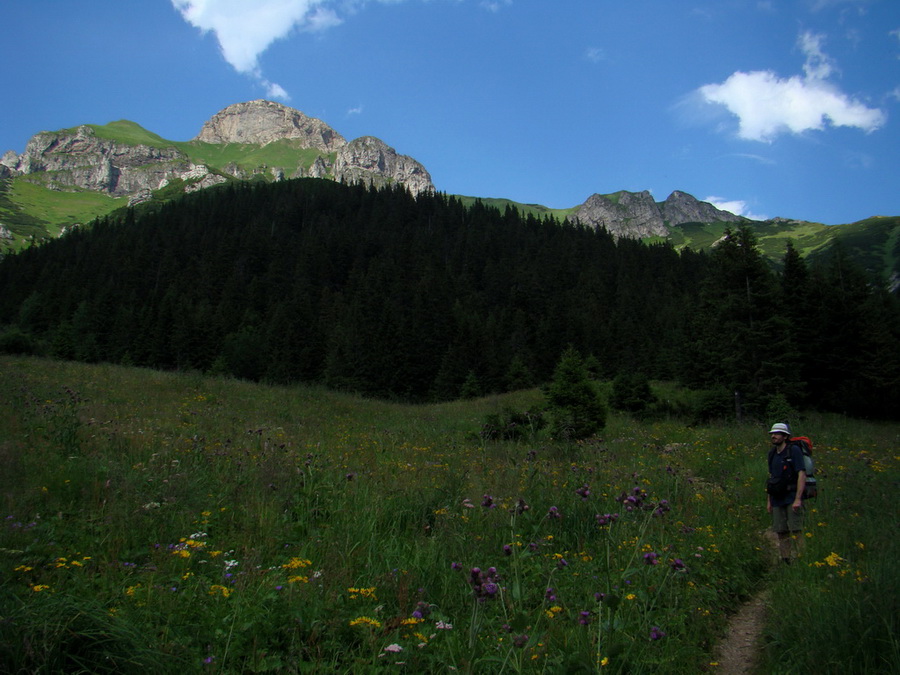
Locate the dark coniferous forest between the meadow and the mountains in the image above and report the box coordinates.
[0,179,900,419]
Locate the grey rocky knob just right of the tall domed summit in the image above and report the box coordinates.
[334,136,434,195]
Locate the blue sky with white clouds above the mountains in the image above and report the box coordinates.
[0,0,900,224]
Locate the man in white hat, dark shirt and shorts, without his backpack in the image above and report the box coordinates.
[766,422,806,564]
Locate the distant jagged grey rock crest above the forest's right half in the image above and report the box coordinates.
[570,190,746,239]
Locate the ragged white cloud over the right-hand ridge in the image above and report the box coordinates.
[697,32,887,142]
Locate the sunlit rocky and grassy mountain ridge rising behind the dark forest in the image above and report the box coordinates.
[0,99,900,288]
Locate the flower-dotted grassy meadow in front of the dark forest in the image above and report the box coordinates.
[0,357,898,673]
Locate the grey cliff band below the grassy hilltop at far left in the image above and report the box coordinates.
[4,126,190,197]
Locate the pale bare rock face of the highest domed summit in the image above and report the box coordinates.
[194,100,347,152]
